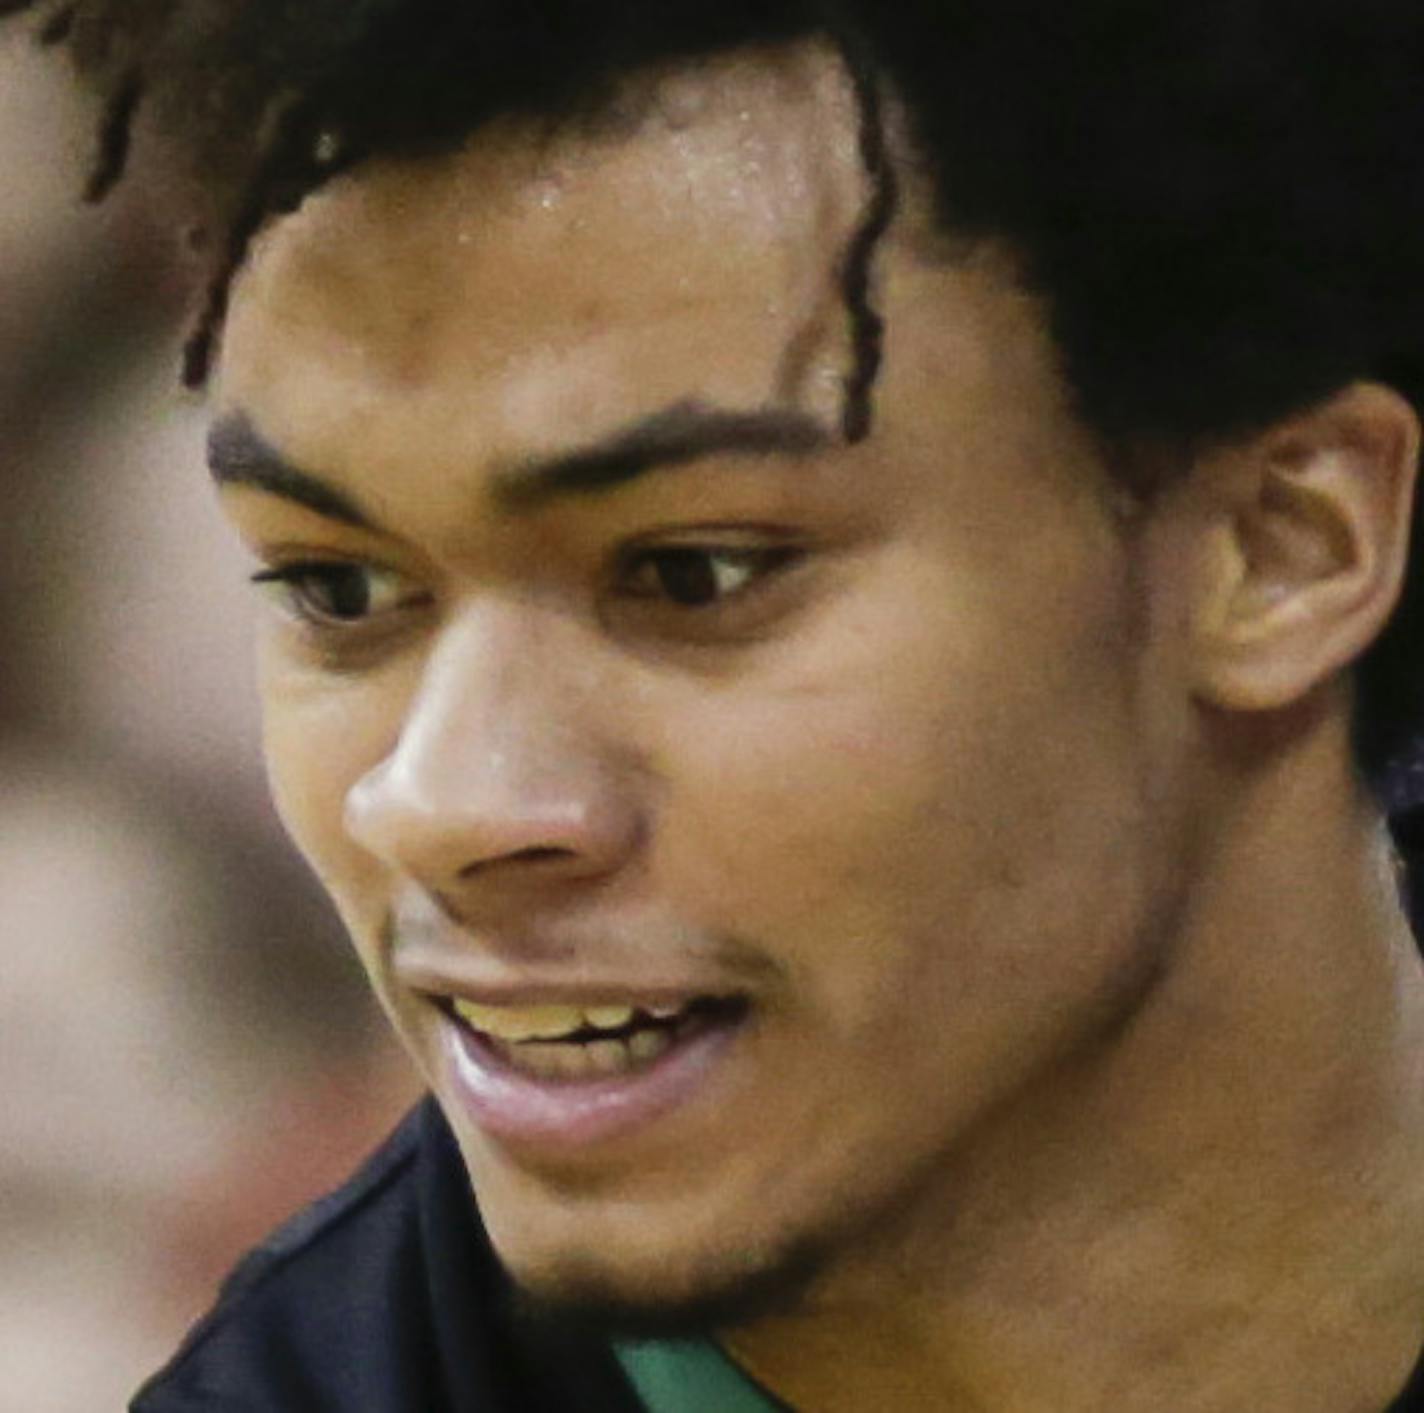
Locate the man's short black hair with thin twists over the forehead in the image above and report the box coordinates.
[16,0,1424,805]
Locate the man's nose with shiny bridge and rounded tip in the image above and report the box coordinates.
[345,611,639,909]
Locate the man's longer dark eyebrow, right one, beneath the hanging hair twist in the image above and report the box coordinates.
[494,402,839,510]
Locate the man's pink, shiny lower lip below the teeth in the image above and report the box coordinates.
[444,1002,745,1149]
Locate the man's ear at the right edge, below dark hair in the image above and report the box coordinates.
[1192,383,1420,712]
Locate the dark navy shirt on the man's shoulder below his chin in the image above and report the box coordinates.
[131,1100,1424,1413]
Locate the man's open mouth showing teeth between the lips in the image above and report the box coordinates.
[443,996,748,1083]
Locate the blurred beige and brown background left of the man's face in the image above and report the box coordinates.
[0,24,416,1413]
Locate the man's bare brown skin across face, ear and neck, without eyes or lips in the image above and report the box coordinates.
[219,50,1424,1413]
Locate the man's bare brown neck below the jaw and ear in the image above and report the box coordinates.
[729,729,1424,1413]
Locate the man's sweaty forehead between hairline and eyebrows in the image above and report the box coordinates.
[219,50,864,481]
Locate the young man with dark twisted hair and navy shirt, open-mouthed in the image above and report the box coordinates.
[23,0,1424,1413]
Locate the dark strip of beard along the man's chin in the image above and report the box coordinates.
[510,1241,827,1340]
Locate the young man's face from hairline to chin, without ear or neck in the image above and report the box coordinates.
[216,54,1190,1312]
